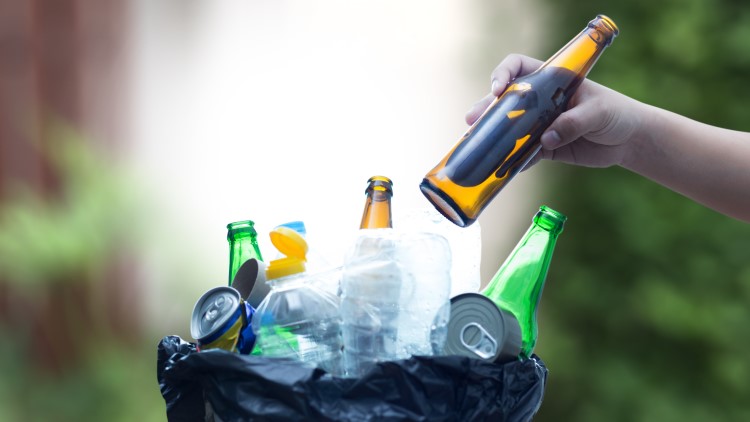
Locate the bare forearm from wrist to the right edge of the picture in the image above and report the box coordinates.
[622,105,750,222]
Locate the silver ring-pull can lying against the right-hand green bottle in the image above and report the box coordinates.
[443,293,521,362]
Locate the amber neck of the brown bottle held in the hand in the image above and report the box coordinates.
[540,15,618,79]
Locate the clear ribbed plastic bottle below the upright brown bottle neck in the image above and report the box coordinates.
[341,228,451,377]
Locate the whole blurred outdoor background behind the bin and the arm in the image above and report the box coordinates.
[0,0,750,421]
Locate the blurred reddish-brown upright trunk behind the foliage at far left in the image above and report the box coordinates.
[0,0,138,373]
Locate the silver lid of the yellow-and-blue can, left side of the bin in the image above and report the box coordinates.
[190,286,240,342]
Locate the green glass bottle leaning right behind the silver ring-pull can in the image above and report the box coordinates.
[482,205,567,358]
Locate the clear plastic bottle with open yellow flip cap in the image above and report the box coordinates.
[252,227,342,376]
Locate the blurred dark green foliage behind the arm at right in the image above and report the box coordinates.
[508,0,750,422]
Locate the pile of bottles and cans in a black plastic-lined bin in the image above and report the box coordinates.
[158,176,565,420]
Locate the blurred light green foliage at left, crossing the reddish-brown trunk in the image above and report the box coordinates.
[0,122,130,293]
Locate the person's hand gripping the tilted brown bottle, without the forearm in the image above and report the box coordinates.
[466,54,644,168]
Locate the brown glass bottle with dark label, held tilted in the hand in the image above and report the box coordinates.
[419,15,618,227]
